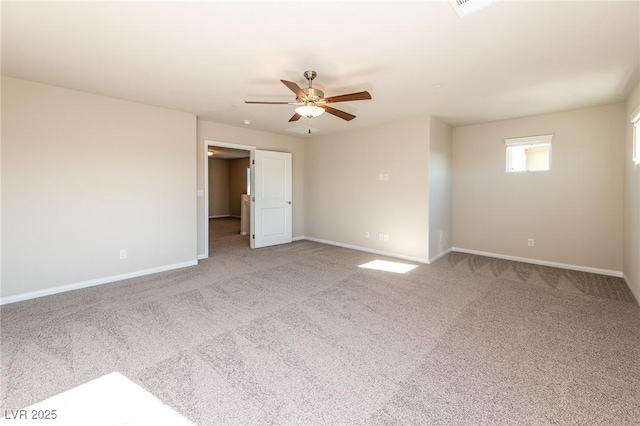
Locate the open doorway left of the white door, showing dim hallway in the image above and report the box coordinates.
[204,140,255,257]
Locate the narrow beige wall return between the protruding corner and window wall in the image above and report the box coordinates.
[429,117,453,259]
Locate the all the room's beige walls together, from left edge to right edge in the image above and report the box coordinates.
[1,77,640,297]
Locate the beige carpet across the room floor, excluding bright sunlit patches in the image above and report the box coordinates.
[0,235,640,425]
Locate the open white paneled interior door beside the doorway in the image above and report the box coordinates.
[251,150,292,248]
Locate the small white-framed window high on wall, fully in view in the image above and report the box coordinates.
[505,135,553,173]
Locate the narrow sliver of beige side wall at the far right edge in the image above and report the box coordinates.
[623,84,640,303]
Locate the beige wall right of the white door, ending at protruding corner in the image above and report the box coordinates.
[305,117,429,260]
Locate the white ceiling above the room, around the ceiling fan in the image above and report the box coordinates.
[1,0,640,137]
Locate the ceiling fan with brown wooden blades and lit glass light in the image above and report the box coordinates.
[244,71,371,121]
